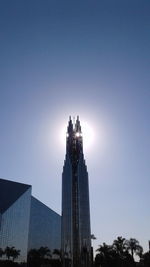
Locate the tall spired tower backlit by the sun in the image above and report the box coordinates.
[61,117,91,267]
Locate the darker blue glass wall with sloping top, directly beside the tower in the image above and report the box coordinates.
[28,197,61,252]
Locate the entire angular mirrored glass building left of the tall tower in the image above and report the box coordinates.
[0,179,61,262]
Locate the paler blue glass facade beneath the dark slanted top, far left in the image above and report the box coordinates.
[0,187,31,262]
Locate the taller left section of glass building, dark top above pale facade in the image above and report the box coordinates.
[0,179,31,262]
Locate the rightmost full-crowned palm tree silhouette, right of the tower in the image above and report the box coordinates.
[126,238,143,260]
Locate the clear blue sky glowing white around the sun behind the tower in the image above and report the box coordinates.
[0,0,150,255]
